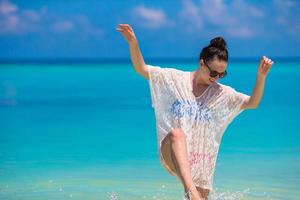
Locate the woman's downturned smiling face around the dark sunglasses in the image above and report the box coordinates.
[199,58,227,85]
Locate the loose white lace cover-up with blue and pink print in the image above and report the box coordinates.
[148,65,250,190]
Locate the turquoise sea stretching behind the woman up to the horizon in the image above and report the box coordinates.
[0,60,300,200]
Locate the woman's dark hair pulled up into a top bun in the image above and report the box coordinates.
[199,37,228,62]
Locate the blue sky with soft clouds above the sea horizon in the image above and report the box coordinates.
[0,0,300,59]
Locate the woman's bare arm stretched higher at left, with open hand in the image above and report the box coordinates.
[116,24,149,79]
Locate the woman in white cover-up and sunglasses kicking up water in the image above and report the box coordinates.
[117,24,273,200]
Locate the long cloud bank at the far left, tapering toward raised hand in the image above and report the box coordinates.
[0,0,104,37]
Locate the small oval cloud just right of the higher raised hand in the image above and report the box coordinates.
[132,5,172,29]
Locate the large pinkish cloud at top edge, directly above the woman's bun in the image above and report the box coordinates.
[178,0,264,38]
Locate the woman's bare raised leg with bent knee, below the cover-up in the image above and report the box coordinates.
[170,129,201,200]
